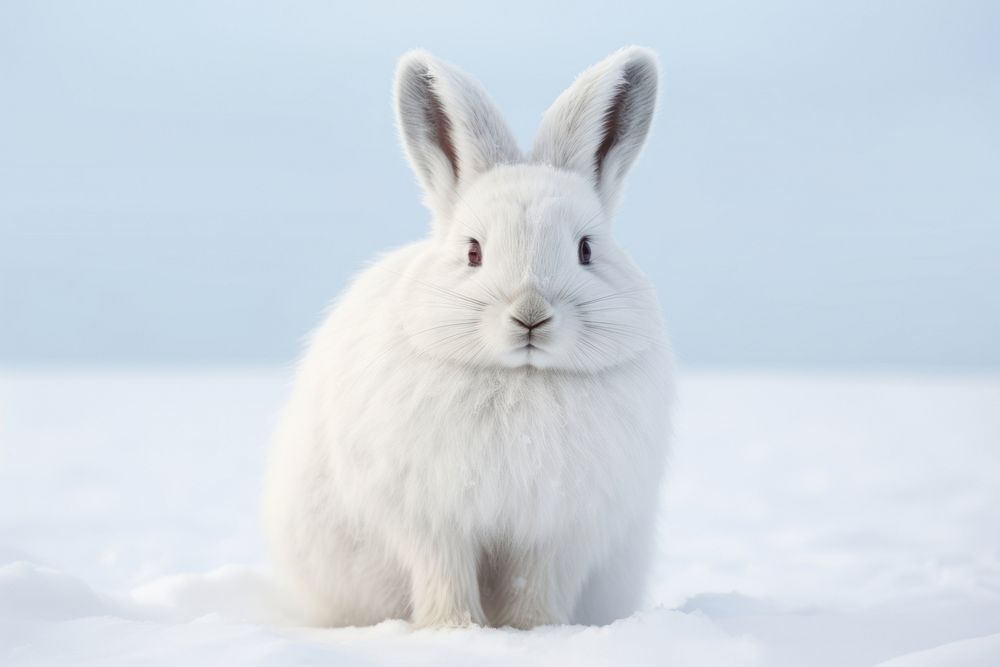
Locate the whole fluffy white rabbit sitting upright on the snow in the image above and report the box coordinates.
[265,47,673,628]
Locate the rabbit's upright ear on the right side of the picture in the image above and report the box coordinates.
[532,46,659,211]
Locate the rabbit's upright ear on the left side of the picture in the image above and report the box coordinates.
[396,50,521,219]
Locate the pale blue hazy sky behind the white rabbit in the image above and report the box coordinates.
[0,0,1000,371]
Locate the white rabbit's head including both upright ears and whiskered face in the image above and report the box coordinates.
[396,47,662,372]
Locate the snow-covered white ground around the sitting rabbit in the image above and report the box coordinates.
[0,371,1000,667]
